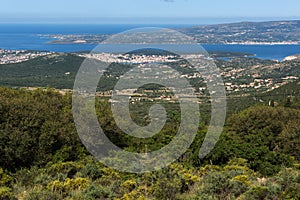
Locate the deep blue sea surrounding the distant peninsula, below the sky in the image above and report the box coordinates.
[0,24,300,60]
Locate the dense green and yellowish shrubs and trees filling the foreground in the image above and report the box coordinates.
[0,88,300,200]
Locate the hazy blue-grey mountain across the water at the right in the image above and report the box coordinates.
[180,20,300,44]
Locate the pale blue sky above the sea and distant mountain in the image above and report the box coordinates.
[0,0,300,23]
